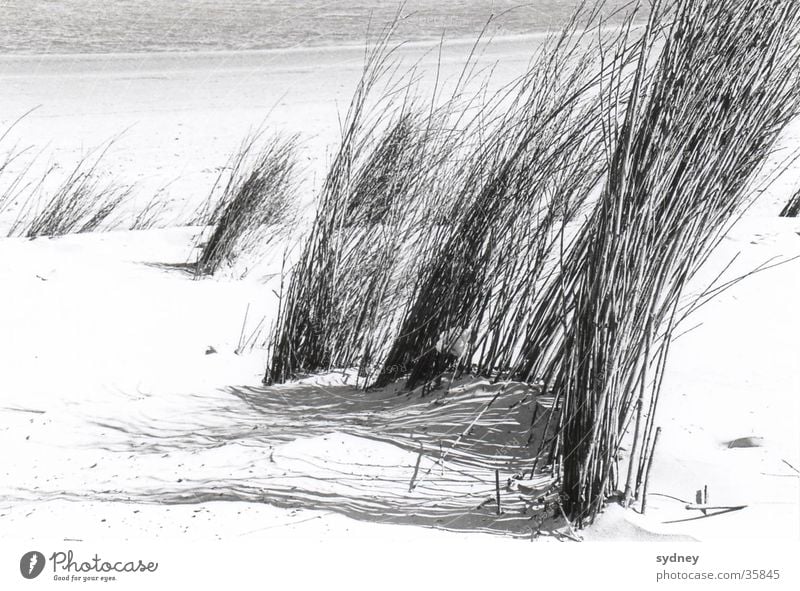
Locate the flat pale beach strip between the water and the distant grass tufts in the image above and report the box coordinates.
[0,35,542,222]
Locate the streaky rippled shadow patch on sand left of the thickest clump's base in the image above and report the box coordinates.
[10,381,562,538]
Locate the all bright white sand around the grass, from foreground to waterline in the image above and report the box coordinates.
[0,38,800,548]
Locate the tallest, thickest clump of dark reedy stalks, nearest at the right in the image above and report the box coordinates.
[523,0,800,525]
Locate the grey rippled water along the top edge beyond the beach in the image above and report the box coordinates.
[0,0,640,54]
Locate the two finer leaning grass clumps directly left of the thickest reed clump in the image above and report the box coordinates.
[268,5,636,385]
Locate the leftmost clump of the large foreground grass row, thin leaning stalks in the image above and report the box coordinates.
[266,15,476,381]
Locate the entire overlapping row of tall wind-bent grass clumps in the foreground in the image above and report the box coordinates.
[266,0,800,526]
